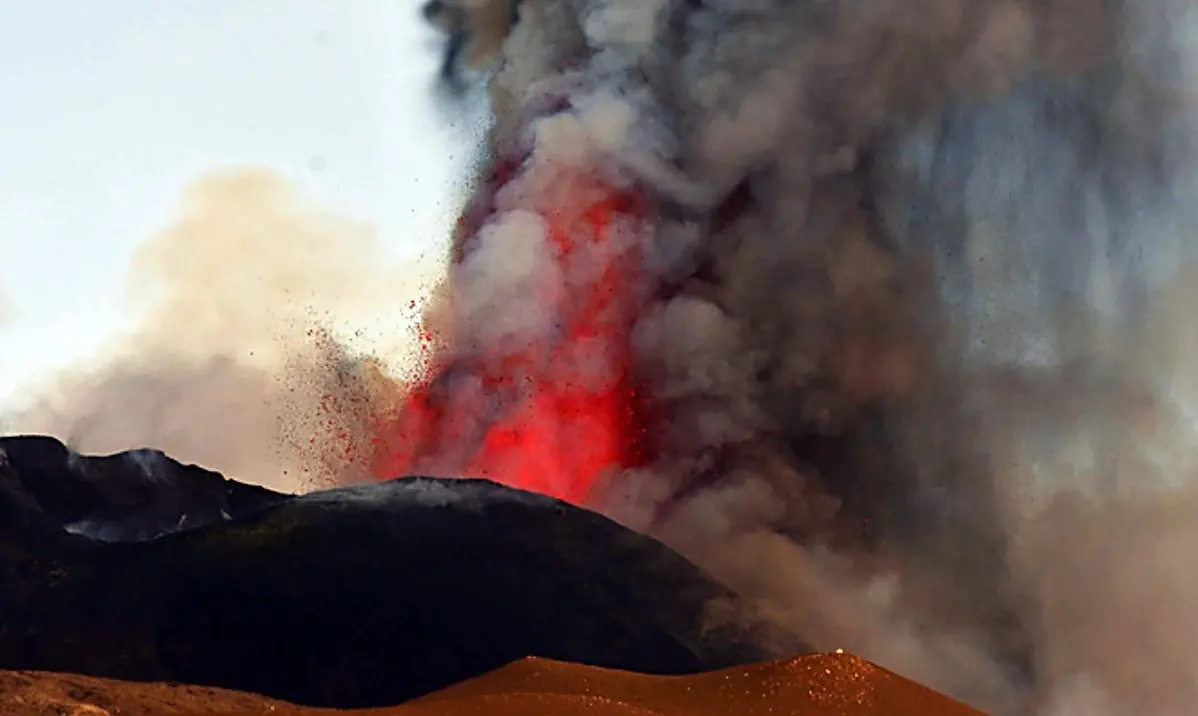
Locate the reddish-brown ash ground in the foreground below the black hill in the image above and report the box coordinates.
[0,654,980,716]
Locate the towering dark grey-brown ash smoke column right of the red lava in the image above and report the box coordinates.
[428,0,1198,716]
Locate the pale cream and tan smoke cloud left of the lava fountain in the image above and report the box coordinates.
[10,169,438,491]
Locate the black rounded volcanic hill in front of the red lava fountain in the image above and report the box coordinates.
[0,440,766,706]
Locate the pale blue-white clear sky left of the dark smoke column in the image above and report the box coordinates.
[0,0,480,407]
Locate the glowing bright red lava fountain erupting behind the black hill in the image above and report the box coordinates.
[375,160,647,504]
